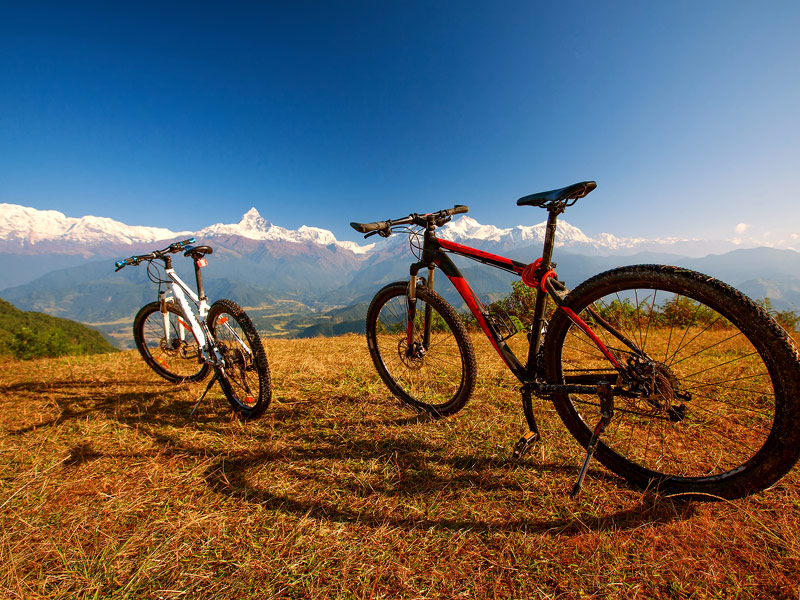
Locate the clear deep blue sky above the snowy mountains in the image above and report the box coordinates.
[0,0,800,247]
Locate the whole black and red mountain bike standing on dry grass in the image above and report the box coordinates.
[351,181,800,498]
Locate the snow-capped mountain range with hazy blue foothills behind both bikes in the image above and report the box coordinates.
[0,204,800,344]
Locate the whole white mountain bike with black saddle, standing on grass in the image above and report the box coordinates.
[115,238,272,419]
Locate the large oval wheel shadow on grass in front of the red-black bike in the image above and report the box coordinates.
[195,439,694,535]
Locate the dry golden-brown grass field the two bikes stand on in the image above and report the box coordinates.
[0,336,800,599]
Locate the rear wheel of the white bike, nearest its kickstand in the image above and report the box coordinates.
[206,300,272,419]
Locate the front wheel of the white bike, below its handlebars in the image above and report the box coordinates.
[133,302,208,383]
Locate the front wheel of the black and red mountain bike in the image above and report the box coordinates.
[367,282,476,417]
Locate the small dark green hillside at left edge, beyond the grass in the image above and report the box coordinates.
[0,298,116,356]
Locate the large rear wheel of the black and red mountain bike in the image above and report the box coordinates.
[544,265,800,498]
